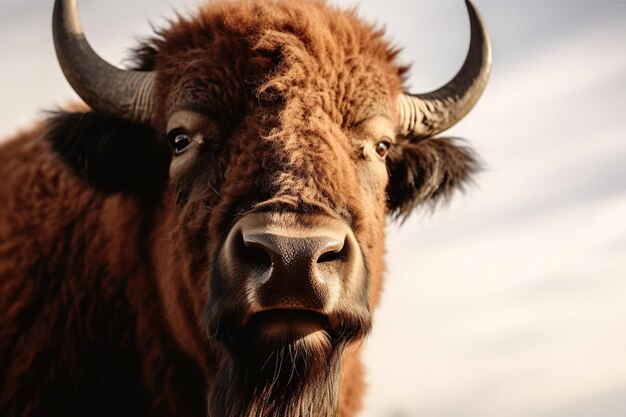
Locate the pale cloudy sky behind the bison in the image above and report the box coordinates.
[0,0,626,417]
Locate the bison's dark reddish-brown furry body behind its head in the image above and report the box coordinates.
[0,128,203,416]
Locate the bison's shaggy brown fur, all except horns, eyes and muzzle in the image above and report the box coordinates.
[0,0,475,417]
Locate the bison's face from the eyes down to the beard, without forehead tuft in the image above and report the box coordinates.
[166,102,394,416]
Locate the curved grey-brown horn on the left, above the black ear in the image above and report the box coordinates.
[52,0,154,123]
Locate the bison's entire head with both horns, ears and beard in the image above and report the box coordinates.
[47,0,491,417]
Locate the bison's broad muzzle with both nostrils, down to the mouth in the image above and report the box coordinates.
[218,212,358,314]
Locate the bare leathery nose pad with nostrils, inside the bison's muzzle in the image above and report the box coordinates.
[241,228,348,311]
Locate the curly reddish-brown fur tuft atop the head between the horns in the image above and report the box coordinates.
[137,0,405,120]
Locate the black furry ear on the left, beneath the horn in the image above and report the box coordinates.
[46,112,171,200]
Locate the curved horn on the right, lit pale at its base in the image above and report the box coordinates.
[398,0,491,138]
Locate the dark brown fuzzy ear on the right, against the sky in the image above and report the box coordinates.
[387,138,480,218]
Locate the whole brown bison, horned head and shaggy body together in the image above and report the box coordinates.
[0,0,491,417]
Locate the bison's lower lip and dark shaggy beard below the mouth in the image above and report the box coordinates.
[208,311,367,417]
